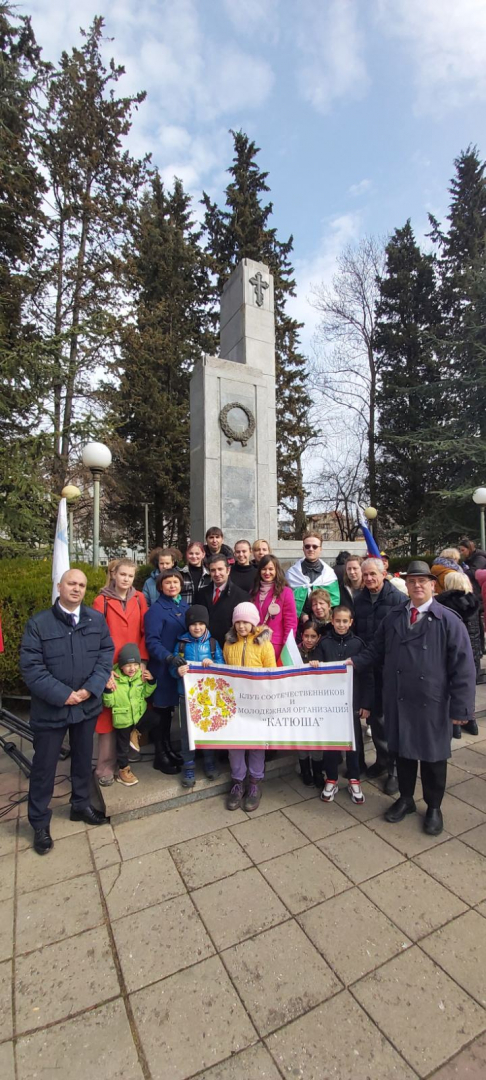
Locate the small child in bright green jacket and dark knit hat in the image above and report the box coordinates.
[103,642,157,787]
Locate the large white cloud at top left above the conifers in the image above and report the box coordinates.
[25,0,273,195]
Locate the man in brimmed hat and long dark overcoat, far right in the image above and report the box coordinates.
[352,559,476,836]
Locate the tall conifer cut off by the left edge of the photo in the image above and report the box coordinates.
[0,3,53,552]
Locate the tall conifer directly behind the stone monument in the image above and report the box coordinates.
[199,131,313,537]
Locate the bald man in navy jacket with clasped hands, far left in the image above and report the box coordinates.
[21,570,113,855]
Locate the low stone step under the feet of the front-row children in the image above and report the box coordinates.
[98,747,297,825]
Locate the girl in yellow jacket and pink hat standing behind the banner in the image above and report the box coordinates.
[222,604,276,810]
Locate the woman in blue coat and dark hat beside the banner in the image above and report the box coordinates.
[145,569,188,774]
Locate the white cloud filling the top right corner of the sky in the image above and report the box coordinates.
[376,0,486,116]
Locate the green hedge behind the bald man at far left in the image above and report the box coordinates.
[0,557,106,693]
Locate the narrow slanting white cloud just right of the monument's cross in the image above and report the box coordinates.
[287,214,361,354]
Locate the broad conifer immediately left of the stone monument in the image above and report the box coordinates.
[109,173,212,545]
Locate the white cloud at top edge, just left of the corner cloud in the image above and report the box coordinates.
[295,0,368,112]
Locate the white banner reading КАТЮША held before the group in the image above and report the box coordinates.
[184,663,355,751]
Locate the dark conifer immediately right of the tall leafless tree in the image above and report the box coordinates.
[375,220,446,555]
